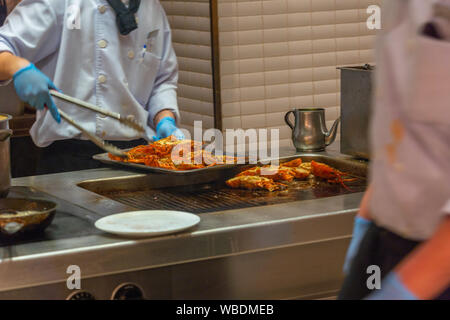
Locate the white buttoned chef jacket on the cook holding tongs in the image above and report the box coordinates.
[0,0,179,146]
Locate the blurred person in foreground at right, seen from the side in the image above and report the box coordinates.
[340,0,450,299]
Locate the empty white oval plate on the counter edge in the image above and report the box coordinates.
[95,210,200,238]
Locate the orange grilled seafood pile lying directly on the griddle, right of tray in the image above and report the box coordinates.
[226,158,356,192]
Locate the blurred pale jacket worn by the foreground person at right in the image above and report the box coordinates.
[369,0,450,240]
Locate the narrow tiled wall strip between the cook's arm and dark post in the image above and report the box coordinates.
[160,0,214,129]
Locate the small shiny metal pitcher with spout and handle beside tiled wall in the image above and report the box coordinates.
[284,108,340,152]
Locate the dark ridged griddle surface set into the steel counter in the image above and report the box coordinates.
[81,155,367,214]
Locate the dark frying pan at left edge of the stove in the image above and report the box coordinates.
[0,198,56,239]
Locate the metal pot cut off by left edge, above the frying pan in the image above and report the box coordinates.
[0,113,12,198]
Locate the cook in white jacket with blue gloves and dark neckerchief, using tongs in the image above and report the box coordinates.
[0,0,182,174]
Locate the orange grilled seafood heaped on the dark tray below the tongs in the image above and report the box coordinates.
[108,136,237,170]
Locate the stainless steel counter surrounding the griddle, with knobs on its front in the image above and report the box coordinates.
[0,149,362,298]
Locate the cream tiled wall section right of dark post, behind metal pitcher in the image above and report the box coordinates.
[218,0,382,145]
